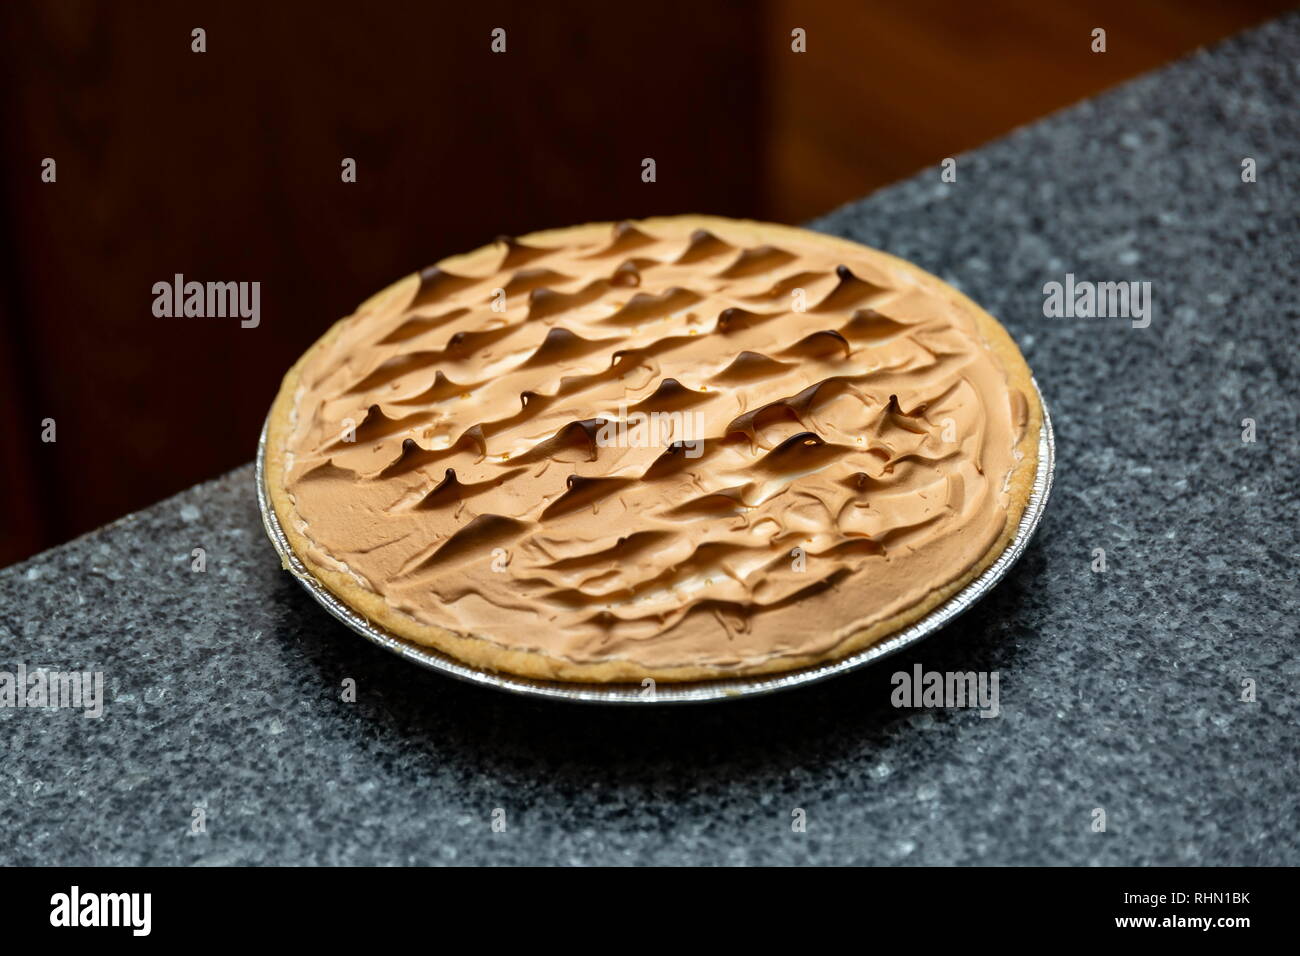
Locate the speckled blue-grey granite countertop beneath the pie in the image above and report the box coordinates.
[0,14,1300,865]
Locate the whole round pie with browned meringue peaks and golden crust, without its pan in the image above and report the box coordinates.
[267,216,1043,682]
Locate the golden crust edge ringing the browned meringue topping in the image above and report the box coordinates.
[265,215,1043,684]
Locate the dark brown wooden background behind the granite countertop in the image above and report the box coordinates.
[0,0,1291,564]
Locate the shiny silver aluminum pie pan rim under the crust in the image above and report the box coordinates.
[255,381,1056,705]
